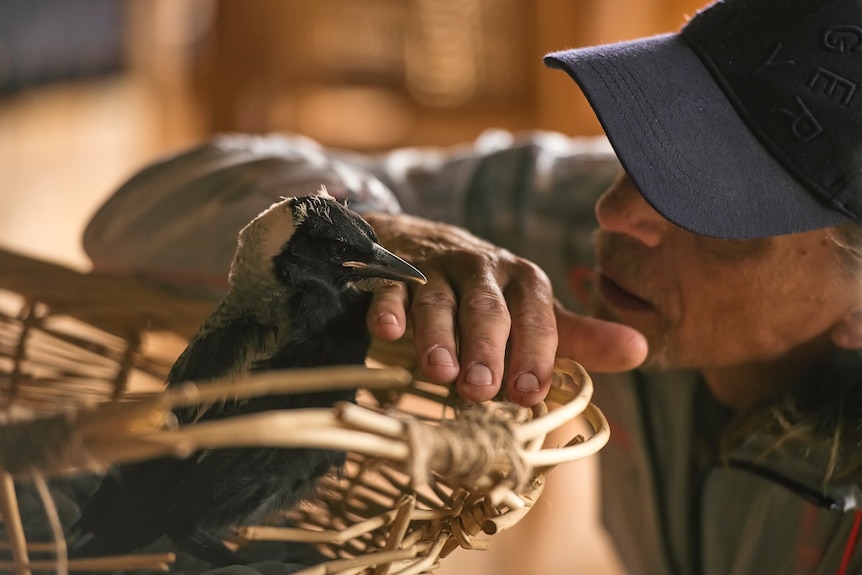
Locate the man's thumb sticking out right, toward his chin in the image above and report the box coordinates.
[555,303,647,373]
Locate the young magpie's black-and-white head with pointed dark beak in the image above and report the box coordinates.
[231,189,426,300]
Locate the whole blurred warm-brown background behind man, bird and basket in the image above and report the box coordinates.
[0,0,704,575]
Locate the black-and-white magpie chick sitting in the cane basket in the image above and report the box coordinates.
[72,190,425,565]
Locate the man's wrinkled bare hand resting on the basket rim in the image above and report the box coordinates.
[365,214,646,406]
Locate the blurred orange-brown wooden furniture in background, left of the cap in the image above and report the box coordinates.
[194,0,702,149]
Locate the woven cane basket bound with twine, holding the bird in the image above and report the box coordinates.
[0,250,608,575]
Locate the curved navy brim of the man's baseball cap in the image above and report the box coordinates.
[545,34,850,239]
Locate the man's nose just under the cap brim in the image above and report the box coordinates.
[596,174,670,248]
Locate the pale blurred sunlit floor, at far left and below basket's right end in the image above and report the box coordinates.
[0,78,622,575]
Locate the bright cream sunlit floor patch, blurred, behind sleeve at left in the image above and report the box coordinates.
[0,77,200,268]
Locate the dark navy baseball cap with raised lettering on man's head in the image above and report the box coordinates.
[545,0,862,239]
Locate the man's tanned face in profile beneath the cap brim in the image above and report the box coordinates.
[595,174,859,369]
